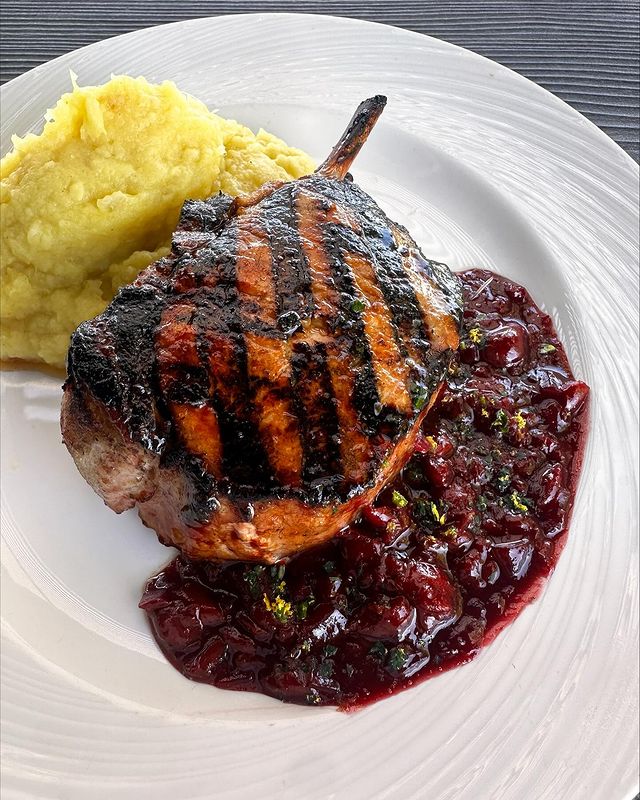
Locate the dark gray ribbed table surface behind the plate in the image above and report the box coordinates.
[0,0,640,160]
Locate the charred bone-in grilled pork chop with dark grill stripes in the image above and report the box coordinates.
[61,96,462,563]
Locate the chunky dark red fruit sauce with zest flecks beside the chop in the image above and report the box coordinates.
[140,270,589,709]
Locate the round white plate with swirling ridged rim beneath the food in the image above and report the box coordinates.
[2,15,638,800]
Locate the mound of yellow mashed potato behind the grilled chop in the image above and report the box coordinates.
[0,76,314,367]
